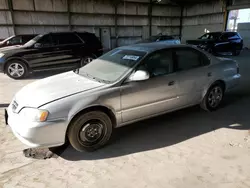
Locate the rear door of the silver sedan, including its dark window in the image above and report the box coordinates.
[174,47,212,106]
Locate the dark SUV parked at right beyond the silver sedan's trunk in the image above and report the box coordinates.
[186,32,243,56]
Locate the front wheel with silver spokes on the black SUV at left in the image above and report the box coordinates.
[5,60,28,79]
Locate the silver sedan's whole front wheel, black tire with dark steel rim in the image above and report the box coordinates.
[68,111,113,152]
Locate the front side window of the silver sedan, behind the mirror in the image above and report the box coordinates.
[141,50,174,77]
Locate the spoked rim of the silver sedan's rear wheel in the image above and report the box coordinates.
[208,87,223,108]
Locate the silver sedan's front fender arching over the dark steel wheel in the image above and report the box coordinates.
[40,87,121,131]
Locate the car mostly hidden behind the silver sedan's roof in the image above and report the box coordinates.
[137,35,180,44]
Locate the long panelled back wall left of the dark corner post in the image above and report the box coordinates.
[0,0,181,48]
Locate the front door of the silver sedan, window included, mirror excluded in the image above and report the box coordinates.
[121,50,178,123]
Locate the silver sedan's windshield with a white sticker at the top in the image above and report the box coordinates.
[79,49,146,83]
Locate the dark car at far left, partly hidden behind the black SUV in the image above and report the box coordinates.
[0,34,37,48]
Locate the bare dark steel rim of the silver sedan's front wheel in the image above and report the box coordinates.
[80,122,103,143]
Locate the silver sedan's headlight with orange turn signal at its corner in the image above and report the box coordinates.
[20,108,49,122]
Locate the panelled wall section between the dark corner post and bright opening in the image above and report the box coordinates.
[182,1,224,43]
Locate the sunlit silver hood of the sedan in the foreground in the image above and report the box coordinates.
[14,71,105,110]
